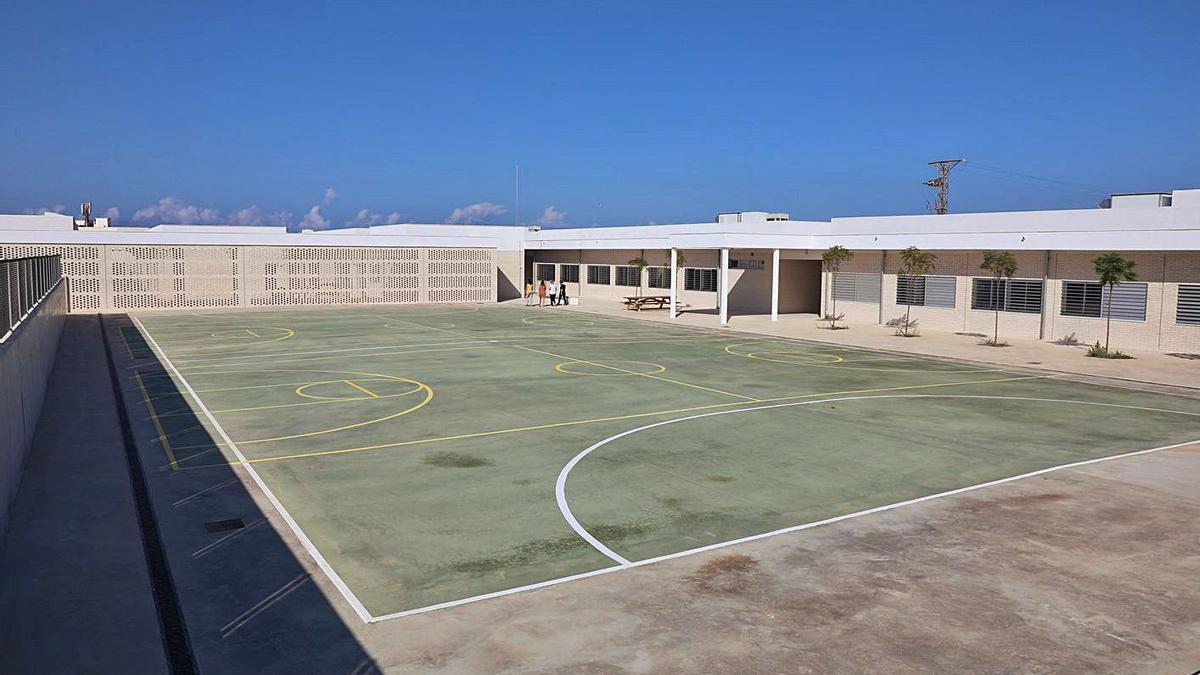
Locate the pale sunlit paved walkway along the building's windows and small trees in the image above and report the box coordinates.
[545,299,1200,390]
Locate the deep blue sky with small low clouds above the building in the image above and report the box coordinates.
[0,0,1200,227]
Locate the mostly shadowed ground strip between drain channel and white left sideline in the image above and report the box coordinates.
[103,315,378,674]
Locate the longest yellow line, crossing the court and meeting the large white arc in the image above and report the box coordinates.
[188,375,1057,468]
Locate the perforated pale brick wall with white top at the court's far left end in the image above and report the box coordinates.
[0,238,497,311]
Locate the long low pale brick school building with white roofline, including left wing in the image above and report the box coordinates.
[0,190,1200,352]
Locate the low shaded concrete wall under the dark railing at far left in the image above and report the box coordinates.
[0,282,67,536]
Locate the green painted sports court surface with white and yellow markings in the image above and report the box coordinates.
[126,306,1200,615]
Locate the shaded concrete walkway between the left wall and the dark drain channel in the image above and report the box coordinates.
[0,315,167,674]
